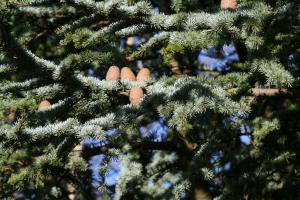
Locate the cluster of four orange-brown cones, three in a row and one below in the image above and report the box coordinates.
[105,66,150,106]
